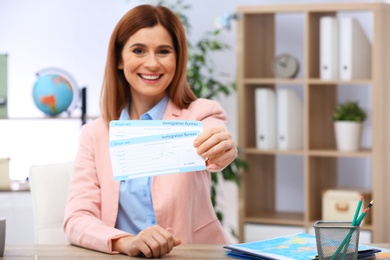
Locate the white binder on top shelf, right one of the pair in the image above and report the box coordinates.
[340,17,371,80]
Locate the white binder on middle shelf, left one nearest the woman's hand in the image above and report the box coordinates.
[255,88,276,150]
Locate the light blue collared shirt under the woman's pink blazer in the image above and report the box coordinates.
[115,96,168,235]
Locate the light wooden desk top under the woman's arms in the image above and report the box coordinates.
[0,245,233,260]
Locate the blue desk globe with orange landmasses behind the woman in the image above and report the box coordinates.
[33,69,78,116]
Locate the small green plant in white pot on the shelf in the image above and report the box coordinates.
[333,101,367,151]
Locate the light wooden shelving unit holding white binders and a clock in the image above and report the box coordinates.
[237,3,390,243]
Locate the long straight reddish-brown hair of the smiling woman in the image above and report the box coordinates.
[100,5,196,123]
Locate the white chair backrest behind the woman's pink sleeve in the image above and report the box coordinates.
[29,162,73,244]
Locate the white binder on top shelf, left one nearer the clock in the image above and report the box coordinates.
[320,16,339,80]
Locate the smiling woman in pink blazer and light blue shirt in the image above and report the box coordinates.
[64,5,237,258]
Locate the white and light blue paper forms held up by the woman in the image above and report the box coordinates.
[110,120,206,180]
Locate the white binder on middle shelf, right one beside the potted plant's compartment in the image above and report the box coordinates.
[276,89,303,150]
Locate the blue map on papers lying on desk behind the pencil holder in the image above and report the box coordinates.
[224,233,387,260]
